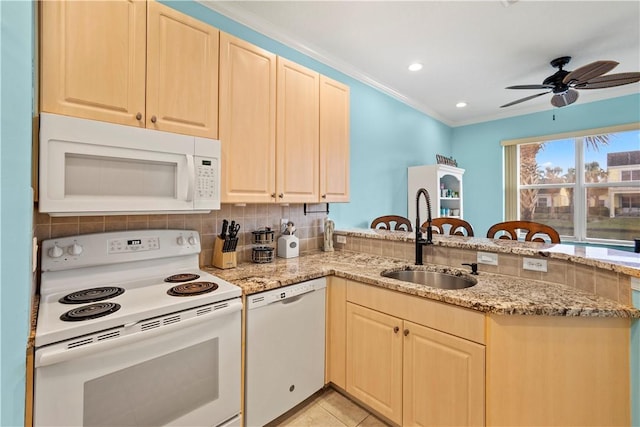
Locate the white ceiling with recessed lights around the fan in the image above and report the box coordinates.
[201,0,640,126]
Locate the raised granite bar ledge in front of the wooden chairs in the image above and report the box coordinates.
[335,228,640,278]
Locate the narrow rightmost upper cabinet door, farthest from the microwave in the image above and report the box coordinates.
[320,76,350,202]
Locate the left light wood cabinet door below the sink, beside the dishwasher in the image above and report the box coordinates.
[347,303,402,424]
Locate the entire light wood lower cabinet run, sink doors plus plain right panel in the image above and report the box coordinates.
[327,278,631,426]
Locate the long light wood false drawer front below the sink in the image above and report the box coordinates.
[347,280,485,344]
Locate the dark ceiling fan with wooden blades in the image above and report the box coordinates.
[500,56,640,108]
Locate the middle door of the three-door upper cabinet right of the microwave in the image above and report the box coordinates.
[276,57,320,203]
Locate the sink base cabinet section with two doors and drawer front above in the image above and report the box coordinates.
[346,281,485,426]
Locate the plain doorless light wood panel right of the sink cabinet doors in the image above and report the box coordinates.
[486,315,631,426]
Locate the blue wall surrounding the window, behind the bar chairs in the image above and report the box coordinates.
[451,94,640,239]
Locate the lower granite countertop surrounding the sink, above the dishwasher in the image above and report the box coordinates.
[207,251,640,318]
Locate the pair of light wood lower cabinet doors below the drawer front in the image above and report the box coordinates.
[347,303,484,426]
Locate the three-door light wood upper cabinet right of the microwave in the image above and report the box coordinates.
[219,33,349,203]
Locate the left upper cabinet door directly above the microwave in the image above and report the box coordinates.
[40,0,146,127]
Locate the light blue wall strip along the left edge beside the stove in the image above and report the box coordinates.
[0,1,33,426]
